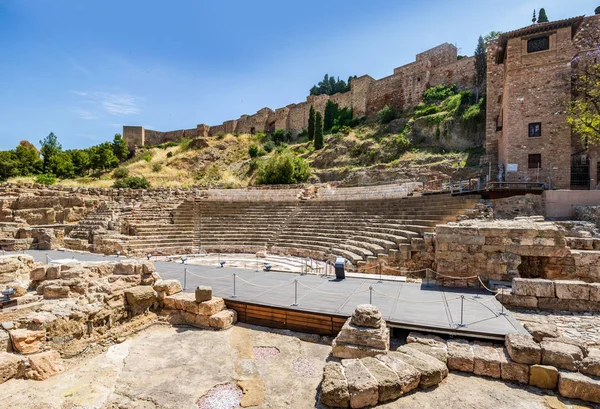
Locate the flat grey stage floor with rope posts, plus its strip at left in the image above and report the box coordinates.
[27,251,525,337]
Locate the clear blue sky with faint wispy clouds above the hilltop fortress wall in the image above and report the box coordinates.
[0,0,600,149]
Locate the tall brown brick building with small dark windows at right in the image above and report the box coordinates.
[486,15,600,189]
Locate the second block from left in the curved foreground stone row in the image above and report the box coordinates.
[342,359,379,408]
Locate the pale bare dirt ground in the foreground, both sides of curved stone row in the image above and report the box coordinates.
[0,324,589,409]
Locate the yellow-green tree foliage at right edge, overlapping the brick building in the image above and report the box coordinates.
[565,60,600,144]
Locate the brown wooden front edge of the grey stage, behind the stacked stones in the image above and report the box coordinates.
[224,298,504,341]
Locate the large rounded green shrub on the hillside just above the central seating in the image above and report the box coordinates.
[256,152,311,185]
